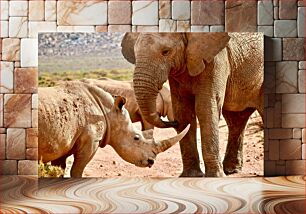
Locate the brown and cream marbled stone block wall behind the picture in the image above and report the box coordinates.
[0,0,306,176]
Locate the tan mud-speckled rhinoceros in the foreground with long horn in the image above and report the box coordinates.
[38,81,189,177]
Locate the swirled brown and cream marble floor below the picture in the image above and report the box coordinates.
[0,176,306,214]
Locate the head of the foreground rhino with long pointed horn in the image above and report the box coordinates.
[108,96,190,167]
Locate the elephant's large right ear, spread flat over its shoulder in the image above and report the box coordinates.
[186,32,230,76]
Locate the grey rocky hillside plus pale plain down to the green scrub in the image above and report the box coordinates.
[38,33,132,72]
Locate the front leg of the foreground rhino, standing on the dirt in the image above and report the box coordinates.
[70,141,99,178]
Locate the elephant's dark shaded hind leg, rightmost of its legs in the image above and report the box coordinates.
[222,108,255,174]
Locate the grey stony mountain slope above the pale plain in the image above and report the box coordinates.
[38,33,124,58]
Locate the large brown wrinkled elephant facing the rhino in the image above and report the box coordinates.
[121,32,264,177]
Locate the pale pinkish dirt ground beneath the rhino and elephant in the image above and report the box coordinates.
[65,112,264,177]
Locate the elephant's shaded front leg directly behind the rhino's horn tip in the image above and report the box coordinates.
[172,94,204,177]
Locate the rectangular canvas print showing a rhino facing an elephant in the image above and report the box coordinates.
[38,32,264,177]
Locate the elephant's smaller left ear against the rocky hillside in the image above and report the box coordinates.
[121,33,139,64]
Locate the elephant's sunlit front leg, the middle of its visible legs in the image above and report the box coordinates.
[196,96,225,177]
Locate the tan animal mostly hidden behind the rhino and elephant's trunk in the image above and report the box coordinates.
[81,78,174,130]
